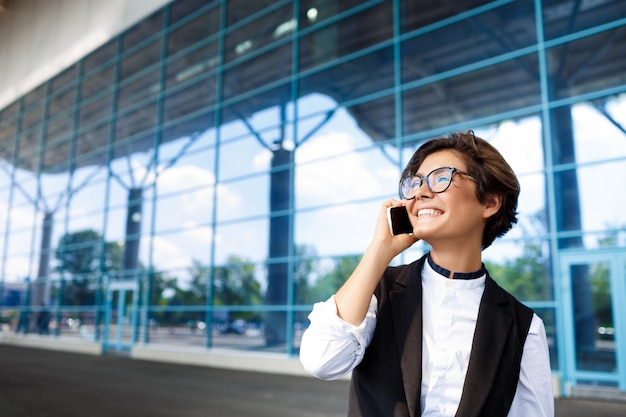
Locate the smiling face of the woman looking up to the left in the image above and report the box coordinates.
[406,150,499,250]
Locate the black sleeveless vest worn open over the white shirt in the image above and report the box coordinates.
[348,256,533,417]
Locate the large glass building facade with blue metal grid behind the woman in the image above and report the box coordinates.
[0,0,626,395]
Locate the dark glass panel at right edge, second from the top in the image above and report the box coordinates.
[546,27,626,100]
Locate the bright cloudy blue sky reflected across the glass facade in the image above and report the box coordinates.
[0,96,626,281]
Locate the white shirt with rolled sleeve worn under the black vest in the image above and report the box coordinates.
[300,262,554,417]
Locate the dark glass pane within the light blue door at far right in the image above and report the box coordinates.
[569,262,617,373]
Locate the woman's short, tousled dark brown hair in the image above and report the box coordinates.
[402,130,520,249]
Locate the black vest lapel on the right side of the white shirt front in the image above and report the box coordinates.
[456,276,513,417]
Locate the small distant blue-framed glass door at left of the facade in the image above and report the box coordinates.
[103,280,138,352]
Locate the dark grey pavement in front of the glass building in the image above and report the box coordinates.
[0,345,626,417]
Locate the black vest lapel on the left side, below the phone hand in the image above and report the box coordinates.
[389,257,425,417]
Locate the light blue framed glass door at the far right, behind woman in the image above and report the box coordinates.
[561,249,626,392]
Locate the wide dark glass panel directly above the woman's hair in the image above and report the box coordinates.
[402,54,541,134]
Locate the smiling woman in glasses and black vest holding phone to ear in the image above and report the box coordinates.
[300,131,554,417]
